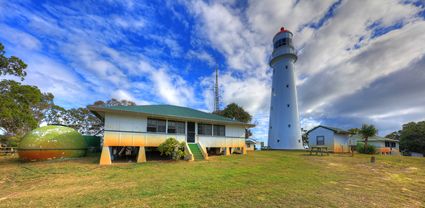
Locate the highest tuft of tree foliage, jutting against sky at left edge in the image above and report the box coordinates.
[0,43,27,80]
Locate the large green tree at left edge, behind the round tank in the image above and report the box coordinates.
[0,80,43,140]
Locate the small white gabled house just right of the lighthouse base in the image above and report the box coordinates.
[307,126,350,152]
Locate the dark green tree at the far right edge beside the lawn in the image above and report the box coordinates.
[400,121,425,154]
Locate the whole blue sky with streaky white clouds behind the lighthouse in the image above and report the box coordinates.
[0,0,425,142]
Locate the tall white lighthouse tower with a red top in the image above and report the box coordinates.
[268,27,303,149]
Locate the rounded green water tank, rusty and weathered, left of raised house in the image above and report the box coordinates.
[18,125,87,161]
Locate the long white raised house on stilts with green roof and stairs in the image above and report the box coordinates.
[88,105,254,165]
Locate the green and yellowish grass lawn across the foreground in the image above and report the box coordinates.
[0,151,425,207]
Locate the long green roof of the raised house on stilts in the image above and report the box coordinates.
[88,105,254,127]
